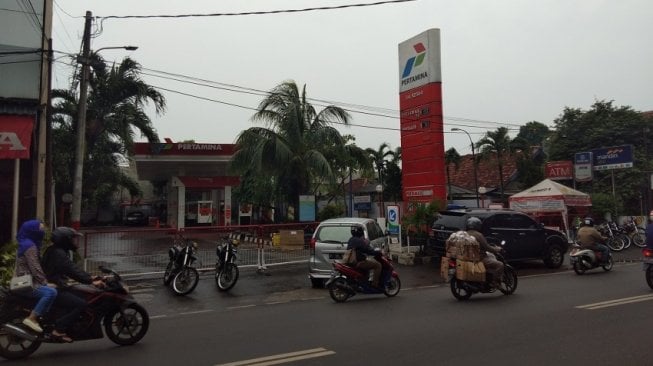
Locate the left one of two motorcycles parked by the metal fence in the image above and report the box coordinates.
[163,234,200,296]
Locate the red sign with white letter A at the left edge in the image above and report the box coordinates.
[0,115,36,159]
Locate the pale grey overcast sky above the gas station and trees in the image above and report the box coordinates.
[53,0,653,153]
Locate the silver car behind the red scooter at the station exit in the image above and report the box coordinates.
[308,217,387,287]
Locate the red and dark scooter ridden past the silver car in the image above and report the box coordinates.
[326,250,401,302]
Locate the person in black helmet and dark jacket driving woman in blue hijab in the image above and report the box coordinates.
[42,226,104,342]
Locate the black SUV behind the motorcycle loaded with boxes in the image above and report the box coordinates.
[429,209,569,268]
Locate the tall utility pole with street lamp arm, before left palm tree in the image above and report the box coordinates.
[70,11,91,229]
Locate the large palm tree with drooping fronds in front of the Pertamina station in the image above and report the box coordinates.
[231,81,350,219]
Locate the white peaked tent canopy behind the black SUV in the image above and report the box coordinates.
[509,179,592,237]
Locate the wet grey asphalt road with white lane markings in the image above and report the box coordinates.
[5,253,653,366]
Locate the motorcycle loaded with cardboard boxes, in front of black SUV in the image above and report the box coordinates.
[448,242,517,300]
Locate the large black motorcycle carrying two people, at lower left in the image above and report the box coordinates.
[0,267,150,360]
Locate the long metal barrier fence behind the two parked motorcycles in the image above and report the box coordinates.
[80,222,318,277]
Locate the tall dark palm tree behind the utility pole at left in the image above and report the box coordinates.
[52,54,166,217]
